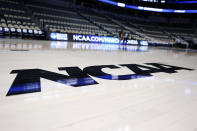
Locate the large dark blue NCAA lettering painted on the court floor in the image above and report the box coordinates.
[7,63,194,96]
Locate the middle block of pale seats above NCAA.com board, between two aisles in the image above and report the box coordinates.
[26,3,107,35]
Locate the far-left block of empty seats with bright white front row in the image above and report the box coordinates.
[0,0,42,37]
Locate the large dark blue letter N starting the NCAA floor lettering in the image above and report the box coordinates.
[7,67,98,96]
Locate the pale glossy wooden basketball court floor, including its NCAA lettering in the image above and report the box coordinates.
[0,39,197,131]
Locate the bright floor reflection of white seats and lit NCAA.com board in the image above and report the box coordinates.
[0,40,148,52]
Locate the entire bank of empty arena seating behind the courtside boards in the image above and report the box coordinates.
[0,0,197,47]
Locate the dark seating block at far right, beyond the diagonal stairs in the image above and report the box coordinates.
[104,12,197,41]
